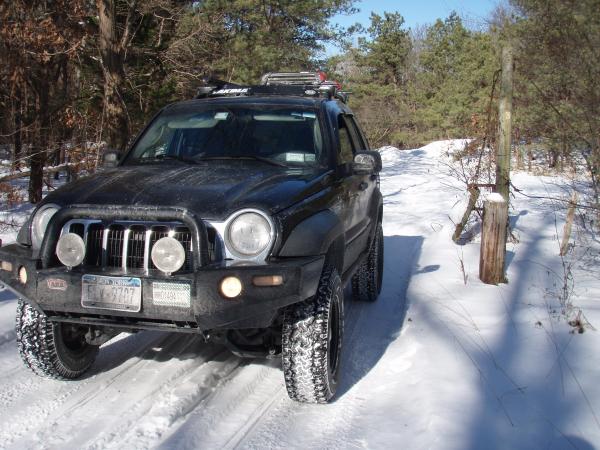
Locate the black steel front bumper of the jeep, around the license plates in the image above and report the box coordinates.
[0,244,324,331]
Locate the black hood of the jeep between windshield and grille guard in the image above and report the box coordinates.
[44,161,328,220]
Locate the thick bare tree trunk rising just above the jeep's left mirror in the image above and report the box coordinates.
[96,0,129,151]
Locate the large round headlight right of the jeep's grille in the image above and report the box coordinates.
[226,212,273,258]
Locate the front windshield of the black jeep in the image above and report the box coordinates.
[125,105,323,166]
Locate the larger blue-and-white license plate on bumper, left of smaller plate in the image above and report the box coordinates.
[81,274,142,312]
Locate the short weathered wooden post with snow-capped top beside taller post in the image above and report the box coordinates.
[479,193,508,284]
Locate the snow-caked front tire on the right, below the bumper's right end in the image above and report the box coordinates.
[282,267,344,403]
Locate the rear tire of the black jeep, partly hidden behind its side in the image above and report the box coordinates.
[352,223,383,302]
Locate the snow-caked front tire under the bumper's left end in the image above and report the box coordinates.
[16,300,98,380]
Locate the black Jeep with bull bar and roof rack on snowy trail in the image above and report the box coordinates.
[0,73,383,403]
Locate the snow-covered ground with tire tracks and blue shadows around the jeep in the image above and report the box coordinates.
[0,141,600,450]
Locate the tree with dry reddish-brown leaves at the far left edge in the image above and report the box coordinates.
[0,0,87,203]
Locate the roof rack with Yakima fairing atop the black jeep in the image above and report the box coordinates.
[195,72,350,103]
